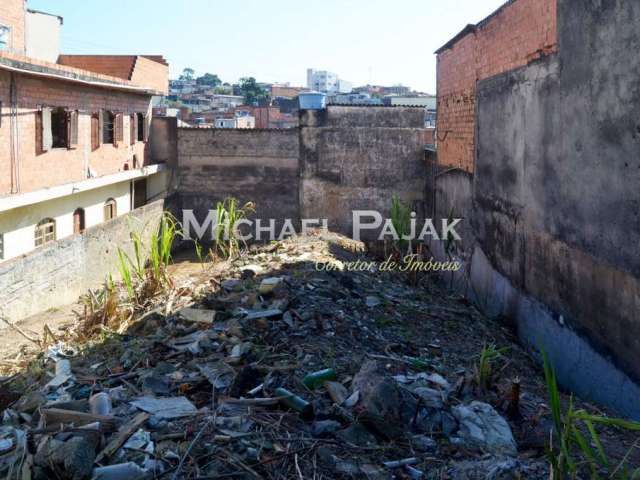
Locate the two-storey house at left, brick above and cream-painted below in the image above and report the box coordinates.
[0,0,168,261]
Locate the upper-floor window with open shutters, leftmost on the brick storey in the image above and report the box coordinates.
[36,107,78,154]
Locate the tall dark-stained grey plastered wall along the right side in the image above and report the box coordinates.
[472,0,640,418]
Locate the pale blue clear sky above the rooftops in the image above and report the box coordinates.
[27,0,505,93]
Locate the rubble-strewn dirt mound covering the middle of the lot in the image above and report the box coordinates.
[0,235,637,480]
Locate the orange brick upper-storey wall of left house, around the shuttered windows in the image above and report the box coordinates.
[0,72,151,196]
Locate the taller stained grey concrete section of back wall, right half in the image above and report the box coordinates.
[300,106,426,238]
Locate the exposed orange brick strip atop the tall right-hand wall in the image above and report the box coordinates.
[437,0,557,172]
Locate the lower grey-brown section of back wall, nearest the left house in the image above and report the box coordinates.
[172,128,300,231]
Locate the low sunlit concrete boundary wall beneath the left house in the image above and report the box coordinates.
[0,200,164,329]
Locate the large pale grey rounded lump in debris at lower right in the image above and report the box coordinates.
[452,401,518,457]
